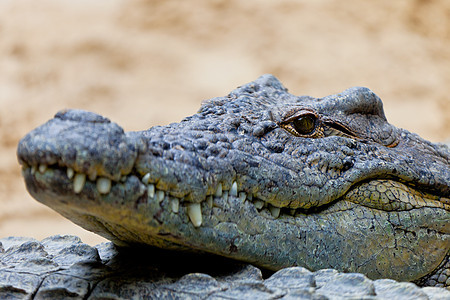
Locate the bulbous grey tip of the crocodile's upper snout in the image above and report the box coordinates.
[17,110,138,182]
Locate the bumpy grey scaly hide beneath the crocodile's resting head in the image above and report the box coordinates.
[0,236,450,299]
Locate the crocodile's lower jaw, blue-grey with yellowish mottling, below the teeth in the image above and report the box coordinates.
[24,164,450,281]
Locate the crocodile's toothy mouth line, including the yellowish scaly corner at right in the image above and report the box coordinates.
[22,163,450,227]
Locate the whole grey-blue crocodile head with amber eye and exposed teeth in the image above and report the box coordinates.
[18,75,450,286]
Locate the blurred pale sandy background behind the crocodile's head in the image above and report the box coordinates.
[0,0,450,244]
